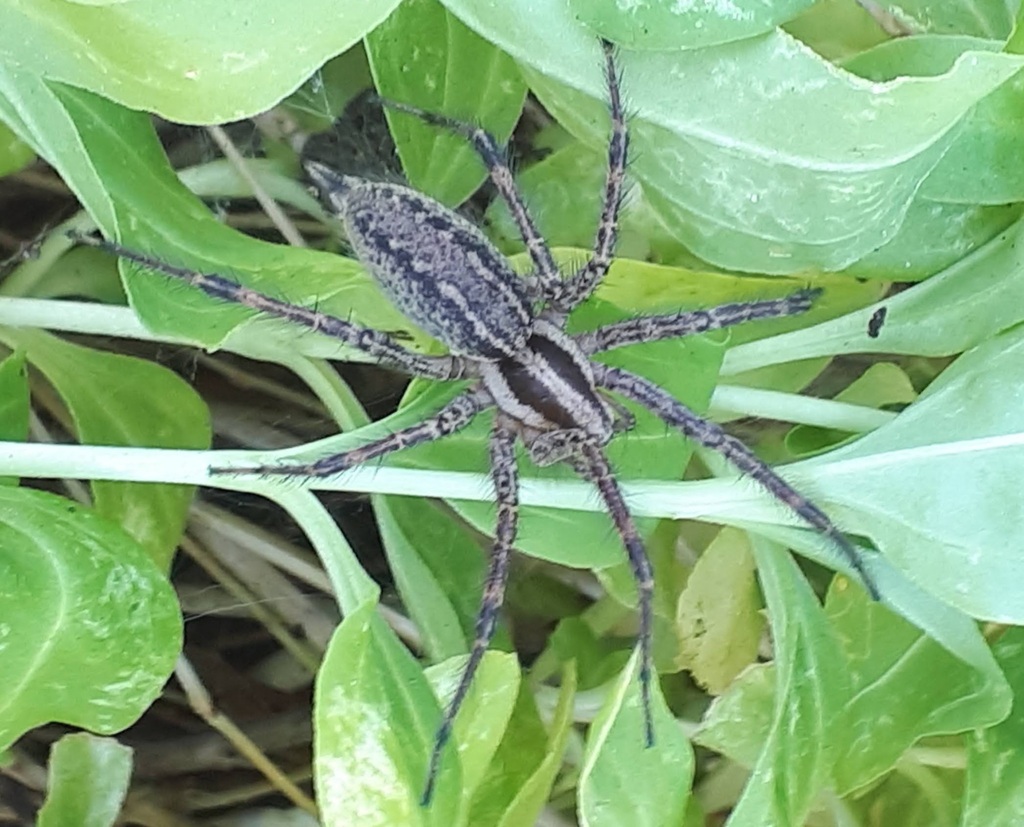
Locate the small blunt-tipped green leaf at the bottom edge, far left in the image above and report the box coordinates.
[37,732,131,827]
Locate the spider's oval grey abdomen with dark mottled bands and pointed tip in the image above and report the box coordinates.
[307,163,534,359]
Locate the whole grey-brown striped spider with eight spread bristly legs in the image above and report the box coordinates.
[79,42,878,804]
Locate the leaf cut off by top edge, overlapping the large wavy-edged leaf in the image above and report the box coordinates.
[568,0,814,50]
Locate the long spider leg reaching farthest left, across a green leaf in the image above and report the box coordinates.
[72,233,471,380]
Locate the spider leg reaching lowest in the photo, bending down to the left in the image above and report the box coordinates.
[420,416,519,807]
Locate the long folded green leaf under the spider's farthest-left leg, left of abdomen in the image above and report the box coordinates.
[0,69,425,360]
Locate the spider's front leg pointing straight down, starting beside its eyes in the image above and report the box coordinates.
[573,442,654,746]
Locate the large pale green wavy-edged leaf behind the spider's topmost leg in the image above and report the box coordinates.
[446,0,1024,273]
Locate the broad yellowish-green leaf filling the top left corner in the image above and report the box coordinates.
[0,0,397,124]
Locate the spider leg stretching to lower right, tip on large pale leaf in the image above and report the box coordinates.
[594,362,880,600]
